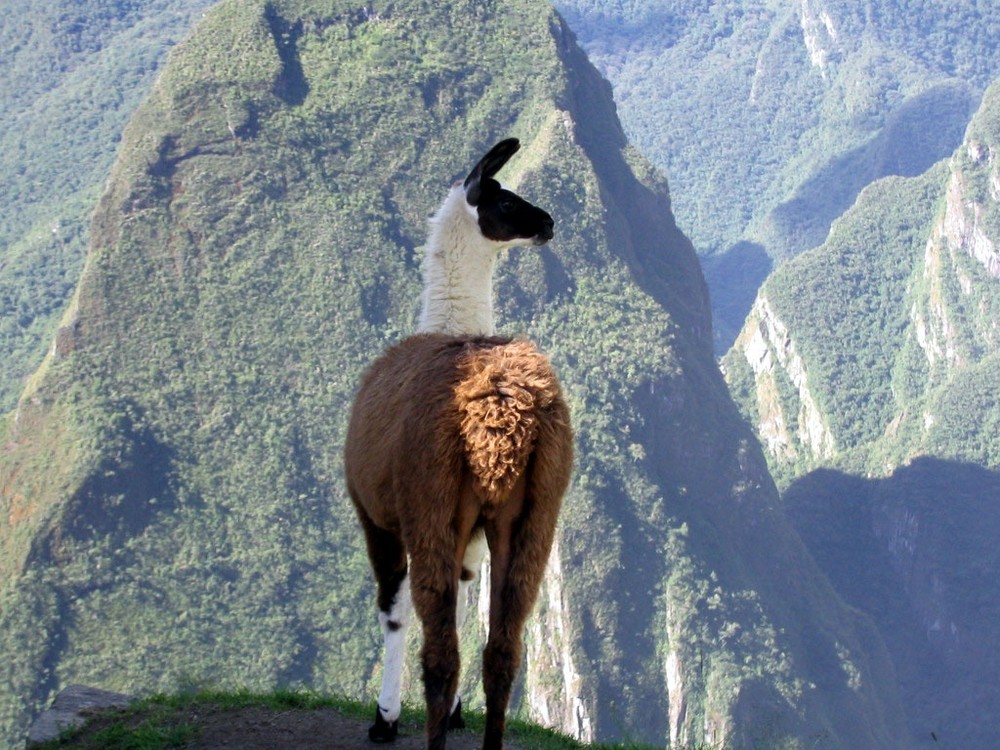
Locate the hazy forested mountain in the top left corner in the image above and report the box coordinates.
[0,0,216,412]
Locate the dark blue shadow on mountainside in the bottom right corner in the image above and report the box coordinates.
[783,456,1000,748]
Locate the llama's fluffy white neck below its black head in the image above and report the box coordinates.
[419,185,497,335]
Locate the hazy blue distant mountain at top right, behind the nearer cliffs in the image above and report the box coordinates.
[556,0,1000,354]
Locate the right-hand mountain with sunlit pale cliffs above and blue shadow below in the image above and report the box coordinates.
[725,78,1000,747]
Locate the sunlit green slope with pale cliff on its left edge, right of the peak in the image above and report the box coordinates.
[724,165,947,478]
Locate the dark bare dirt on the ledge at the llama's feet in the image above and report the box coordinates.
[69,707,521,750]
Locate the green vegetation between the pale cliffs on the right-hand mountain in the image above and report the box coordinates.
[725,165,947,482]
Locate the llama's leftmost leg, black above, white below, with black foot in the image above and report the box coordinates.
[364,523,413,742]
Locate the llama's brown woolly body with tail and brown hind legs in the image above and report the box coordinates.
[345,334,573,748]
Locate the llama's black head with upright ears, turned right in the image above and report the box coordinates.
[465,138,555,246]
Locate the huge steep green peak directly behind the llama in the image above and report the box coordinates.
[0,0,907,748]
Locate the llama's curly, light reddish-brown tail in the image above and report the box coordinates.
[455,340,561,503]
